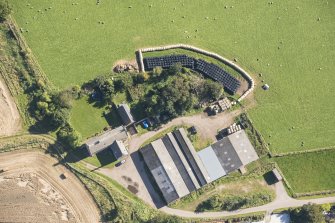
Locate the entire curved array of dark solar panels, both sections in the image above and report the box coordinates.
[143,55,241,94]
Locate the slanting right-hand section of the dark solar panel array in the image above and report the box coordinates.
[195,59,241,93]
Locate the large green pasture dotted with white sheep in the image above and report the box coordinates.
[11,0,335,152]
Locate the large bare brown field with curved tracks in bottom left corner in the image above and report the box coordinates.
[0,151,100,223]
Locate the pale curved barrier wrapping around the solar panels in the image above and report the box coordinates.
[137,44,255,102]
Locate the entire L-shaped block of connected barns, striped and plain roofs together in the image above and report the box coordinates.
[140,128,258,203]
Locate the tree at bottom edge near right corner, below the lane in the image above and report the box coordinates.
[290,204,325,223]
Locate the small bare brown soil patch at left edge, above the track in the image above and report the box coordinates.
[0,78,21,137]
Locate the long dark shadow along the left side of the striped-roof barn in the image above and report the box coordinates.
[130,151,166,209]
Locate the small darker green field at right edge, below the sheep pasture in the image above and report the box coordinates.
[275,150,335,193]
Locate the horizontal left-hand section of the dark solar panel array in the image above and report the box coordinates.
[143,55,194,70]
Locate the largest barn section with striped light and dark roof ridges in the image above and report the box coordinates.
[140,128,209,203]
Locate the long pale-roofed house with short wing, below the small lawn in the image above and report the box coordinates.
[85,126,128,159]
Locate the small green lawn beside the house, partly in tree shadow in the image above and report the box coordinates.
[70,96,121,139]
